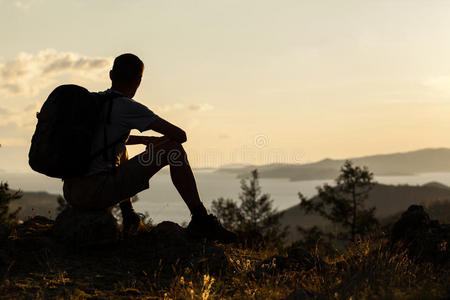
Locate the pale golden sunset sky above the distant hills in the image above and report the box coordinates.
[0,0,450,171]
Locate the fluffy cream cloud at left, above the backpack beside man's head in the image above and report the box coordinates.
[0,49,112,96]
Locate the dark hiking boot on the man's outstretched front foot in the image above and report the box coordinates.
[187,214,237,244]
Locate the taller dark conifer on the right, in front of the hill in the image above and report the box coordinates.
[299,160,379,241]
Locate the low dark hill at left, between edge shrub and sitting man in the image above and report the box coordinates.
[9,192,58,220]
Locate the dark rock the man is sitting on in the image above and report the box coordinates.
[53,207,120,248]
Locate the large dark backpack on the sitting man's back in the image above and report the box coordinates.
[28,84,122,179]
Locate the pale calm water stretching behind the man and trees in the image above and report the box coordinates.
[0,170,450,223]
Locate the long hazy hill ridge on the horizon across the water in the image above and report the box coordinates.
[218,148,450,181]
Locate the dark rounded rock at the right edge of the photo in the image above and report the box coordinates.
[390,205,450,265]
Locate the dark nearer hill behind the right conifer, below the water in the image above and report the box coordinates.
[281,182,450,240]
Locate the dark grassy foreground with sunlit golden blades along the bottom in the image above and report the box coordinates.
[0,234,450,299]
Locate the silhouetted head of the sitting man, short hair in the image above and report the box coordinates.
[109,53,144,98]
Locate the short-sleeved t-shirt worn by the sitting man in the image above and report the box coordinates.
[86,89,159,175]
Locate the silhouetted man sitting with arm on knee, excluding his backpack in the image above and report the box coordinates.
[63,54,236,242]
